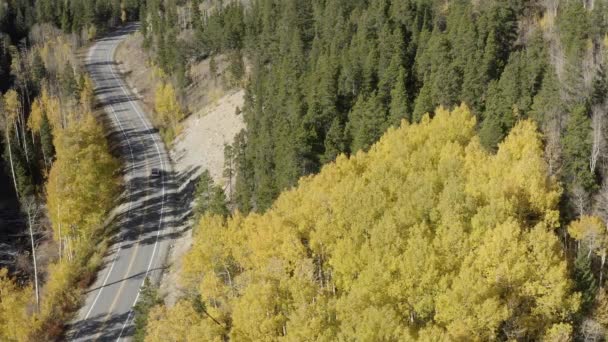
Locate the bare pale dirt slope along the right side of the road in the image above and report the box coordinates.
[116,32,245,305]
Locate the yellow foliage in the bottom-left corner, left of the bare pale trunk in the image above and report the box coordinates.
[0,268,35,341]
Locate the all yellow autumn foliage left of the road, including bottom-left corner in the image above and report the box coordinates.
[0,82,119,341]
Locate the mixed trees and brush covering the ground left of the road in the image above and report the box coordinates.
[0,0,131,341]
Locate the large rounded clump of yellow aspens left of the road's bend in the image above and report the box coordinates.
[46,113,119,246]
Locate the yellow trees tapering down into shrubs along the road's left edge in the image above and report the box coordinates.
[29,89,119,338]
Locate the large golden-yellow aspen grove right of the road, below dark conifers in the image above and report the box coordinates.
[149,106,579,341]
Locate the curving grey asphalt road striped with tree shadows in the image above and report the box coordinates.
[66,25,173,341]
